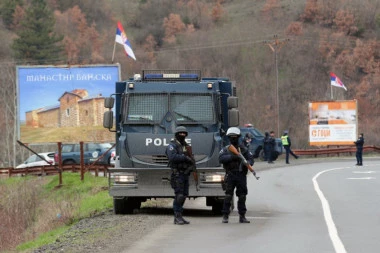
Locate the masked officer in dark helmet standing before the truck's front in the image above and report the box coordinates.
[166,126,195,225]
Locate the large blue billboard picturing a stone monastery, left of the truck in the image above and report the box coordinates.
[16,64,120,143]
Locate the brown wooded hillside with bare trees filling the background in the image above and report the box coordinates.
[0,0,380,167]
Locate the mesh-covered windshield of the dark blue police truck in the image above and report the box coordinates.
[124,93,215,124]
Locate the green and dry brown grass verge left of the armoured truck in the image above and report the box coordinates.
[0,172,112,252]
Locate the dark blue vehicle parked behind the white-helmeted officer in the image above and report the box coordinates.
[239,124,283,160]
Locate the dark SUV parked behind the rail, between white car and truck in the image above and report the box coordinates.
[54,143,115,165]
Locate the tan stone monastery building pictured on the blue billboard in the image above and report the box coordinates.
[25,89,105,128]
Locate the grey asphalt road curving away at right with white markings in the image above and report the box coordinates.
[125,158,380,253]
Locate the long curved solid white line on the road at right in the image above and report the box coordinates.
[313,168,347,253]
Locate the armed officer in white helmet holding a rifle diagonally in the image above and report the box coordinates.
[219,127,254,223]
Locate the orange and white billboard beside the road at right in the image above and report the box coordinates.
[309,100,358,146]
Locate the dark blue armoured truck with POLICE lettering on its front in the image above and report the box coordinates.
[103,70,239,214]
